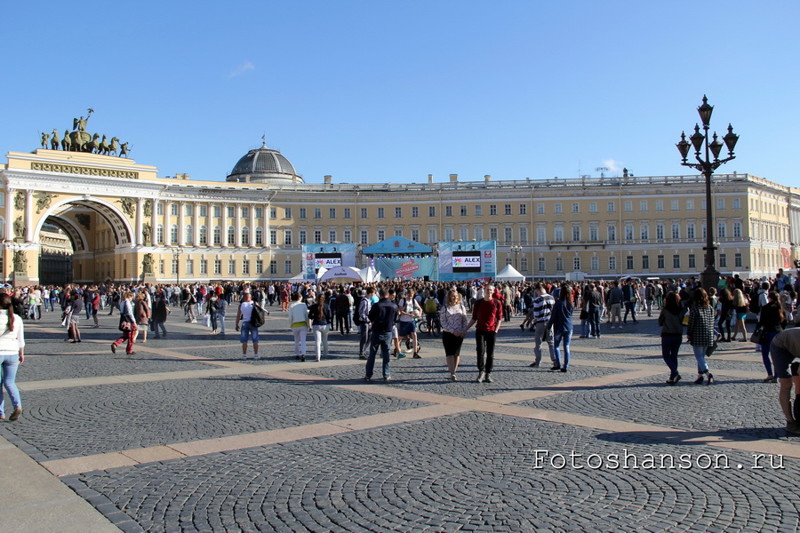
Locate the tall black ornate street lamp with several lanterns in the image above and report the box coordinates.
[676,95,739,289]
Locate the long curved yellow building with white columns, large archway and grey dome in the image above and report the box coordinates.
[0,141,800,284]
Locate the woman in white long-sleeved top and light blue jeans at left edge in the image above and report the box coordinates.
[0,293,25,421]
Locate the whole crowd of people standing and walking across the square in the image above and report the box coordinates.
[0,270,800,432]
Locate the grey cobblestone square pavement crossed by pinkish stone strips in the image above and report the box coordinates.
[0,311,800,532]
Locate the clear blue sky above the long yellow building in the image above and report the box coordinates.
[0,0,800,187]
